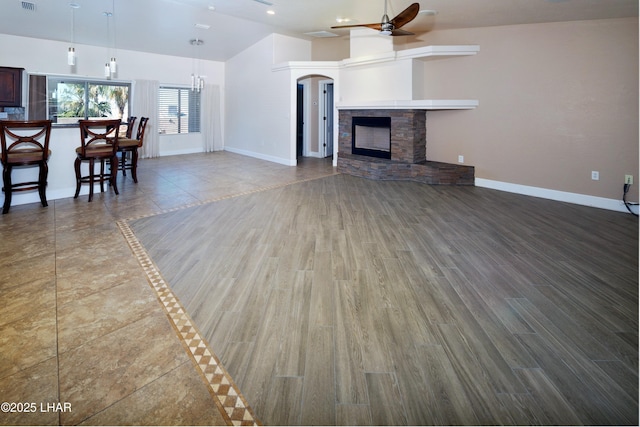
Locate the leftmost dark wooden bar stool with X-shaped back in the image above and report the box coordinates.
[0,120,51,214]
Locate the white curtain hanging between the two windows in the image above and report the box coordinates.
[131,80,160,158]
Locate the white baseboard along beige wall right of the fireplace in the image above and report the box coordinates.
[475,178,628,212]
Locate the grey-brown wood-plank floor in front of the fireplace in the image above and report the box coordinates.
[130,170,638,425]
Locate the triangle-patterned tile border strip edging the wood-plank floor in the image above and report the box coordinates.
[116,173,335,426]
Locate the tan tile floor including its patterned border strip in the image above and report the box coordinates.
[0,152,335,425]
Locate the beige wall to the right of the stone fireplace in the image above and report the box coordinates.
[406,19,640,201]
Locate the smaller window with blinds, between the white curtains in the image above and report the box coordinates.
[158,86,200,134]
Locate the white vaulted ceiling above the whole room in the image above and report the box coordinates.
[0,0,638,61]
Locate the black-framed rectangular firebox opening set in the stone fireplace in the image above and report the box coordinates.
[351,117,391,159]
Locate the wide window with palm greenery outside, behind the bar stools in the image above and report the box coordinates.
[47,77,131,124]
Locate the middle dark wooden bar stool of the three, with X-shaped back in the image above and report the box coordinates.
[73,119,120,201]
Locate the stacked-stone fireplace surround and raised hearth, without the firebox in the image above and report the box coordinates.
[338,109,475,185]
